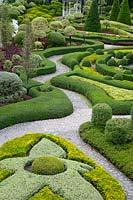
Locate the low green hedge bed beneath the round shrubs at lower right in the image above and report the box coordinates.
[79,122,133,180]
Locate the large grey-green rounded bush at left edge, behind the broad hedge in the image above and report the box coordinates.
[0,72,26,103]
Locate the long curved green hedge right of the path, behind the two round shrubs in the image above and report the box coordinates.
[51,73,133,115]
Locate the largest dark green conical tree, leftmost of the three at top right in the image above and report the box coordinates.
[84,0,101,32]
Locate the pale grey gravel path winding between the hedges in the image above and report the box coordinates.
[0,56,133,200]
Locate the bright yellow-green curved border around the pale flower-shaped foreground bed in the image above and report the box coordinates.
[0,134,125,200]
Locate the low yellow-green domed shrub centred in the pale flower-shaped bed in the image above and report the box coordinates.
[31,156,65,175]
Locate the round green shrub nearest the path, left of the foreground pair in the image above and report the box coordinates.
[91,103,112,127]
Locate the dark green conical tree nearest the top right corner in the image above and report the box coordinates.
[117,0,131,25]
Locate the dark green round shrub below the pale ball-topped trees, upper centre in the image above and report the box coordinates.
[48,32,65,46]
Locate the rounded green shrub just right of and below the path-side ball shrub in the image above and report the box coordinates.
[105,118,131,144]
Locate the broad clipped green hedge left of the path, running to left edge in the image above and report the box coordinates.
[0,87,73,129]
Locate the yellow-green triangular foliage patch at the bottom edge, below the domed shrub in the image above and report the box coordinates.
[28,186,64,200]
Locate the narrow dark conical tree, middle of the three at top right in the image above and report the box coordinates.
[110,0,120,21]
